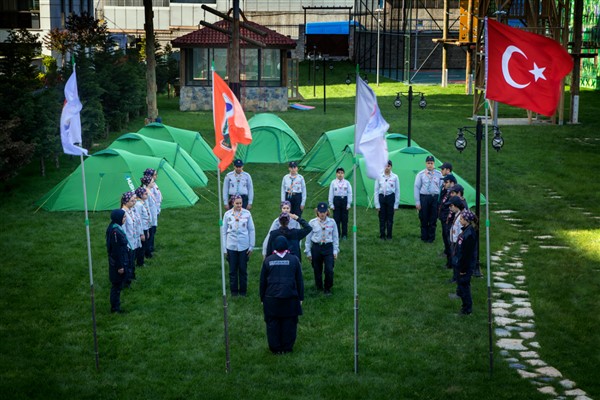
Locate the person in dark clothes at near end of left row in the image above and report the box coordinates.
[106,209,130,314]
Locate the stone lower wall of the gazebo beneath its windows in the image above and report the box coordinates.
[179,86,288,112]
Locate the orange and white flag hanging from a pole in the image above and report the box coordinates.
[213,71,252,172]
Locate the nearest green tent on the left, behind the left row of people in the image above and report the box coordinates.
[36,149,198,211]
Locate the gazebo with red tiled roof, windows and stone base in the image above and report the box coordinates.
[172,20,296,111]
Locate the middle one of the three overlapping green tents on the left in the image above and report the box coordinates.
[109,133,208,188]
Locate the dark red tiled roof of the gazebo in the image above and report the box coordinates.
[171,20,296,49]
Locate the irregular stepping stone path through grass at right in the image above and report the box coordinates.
[491,209,591,400]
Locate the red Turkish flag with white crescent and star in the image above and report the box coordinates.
[485,18,573,116]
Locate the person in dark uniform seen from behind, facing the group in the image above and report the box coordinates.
[260,236,304,354]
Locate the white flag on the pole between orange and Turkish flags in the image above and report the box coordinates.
[354,76,390,179]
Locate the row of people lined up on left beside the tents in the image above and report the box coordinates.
[106,168,162,314]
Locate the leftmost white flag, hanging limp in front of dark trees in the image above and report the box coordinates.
[60,65,87,156]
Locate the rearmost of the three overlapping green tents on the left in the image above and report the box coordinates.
[138,122,219,171]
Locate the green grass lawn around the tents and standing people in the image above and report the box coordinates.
[0,61,600,399]
